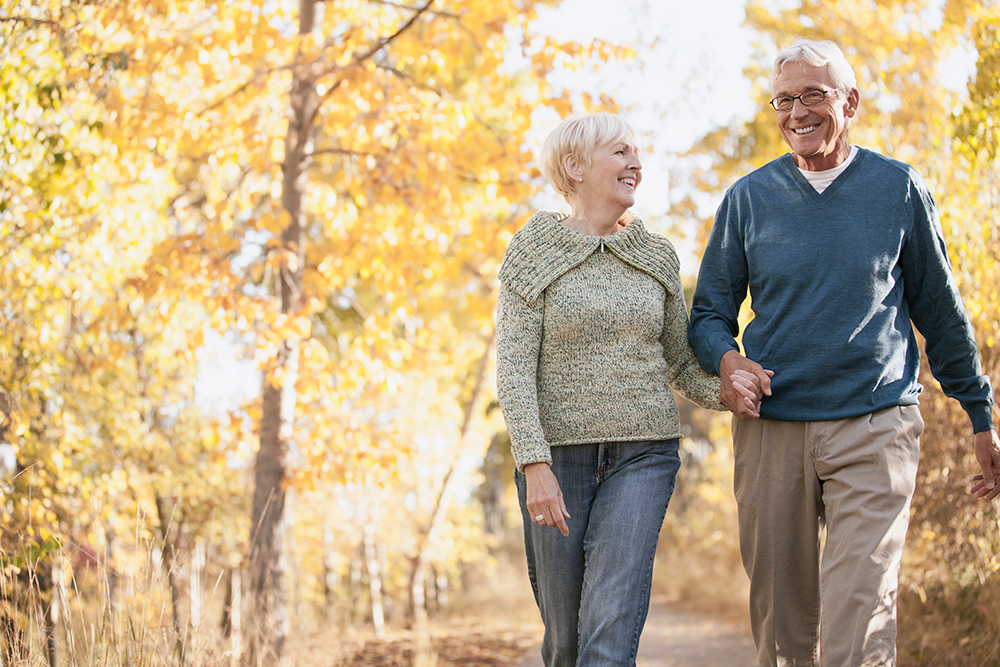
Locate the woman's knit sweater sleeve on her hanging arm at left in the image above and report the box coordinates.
[497,285,552,471]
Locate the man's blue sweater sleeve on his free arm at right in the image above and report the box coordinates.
[901,175,993,433]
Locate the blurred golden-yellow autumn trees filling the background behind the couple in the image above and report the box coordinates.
[0,0,1000,666]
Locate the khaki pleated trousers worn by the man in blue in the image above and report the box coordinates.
[733,406,924,667]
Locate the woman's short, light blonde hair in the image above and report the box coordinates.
[539,111,639,197]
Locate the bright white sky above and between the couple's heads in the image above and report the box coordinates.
[531,0,753,253]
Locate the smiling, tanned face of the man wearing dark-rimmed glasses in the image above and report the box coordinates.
[774,62,858,171]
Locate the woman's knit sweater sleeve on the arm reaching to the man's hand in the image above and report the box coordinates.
[660,268,727,411]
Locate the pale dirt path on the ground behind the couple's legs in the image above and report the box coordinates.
[520,603,757,667]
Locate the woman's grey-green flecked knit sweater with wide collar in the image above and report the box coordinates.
[497,212,725,470]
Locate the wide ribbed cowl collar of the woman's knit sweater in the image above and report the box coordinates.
[499,211,680,302]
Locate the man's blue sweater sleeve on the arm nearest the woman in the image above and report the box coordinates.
[688,190,749,373]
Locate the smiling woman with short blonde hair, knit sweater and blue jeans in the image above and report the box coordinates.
[497,113,759,667]
